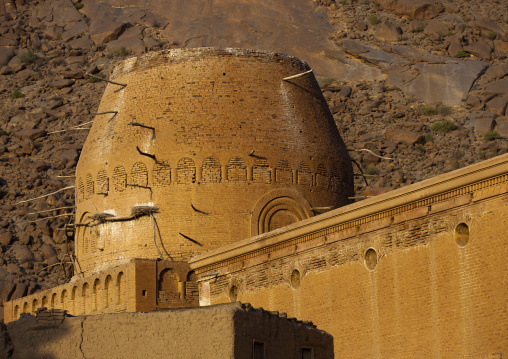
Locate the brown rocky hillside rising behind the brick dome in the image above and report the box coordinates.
[0,0,508,320]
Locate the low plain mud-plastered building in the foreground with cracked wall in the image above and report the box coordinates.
[4,303,333,359]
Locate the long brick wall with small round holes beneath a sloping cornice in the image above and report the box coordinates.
[191,155,508,358]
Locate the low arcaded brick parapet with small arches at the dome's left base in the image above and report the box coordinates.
[4,259,198,322]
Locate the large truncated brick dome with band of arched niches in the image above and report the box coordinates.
[76,48,353,273]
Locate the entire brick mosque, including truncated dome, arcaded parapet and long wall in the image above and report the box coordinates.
[4,48,508,358]
